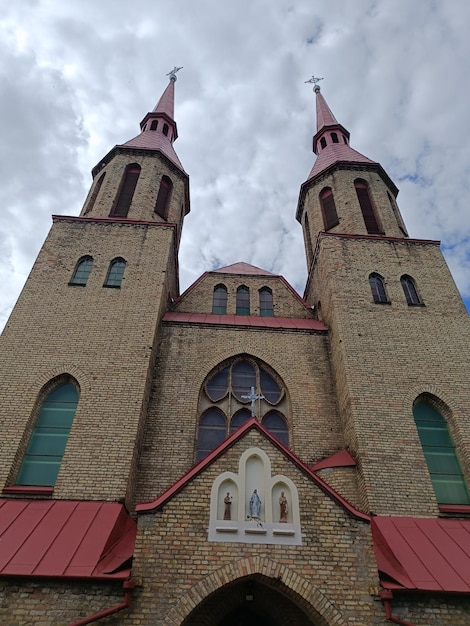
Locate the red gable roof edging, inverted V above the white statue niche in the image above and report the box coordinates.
[135,417,370,522]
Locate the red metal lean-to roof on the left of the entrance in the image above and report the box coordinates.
[0,499,137,580]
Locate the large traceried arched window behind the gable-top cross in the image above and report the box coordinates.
[196,357,289,461]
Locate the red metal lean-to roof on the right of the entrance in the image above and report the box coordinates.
[371,517,470,593]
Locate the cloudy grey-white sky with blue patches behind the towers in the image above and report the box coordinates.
[0,0,470,327]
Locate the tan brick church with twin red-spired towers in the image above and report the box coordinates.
[0,73,470,626]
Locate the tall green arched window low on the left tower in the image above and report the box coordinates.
[16,383,78,487]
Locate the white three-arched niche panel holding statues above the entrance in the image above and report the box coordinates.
[209,448,302,545]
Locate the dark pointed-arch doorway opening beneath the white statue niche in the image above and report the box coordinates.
[182,574,328,626]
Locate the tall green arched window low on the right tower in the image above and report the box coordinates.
[413,400,470,504]
